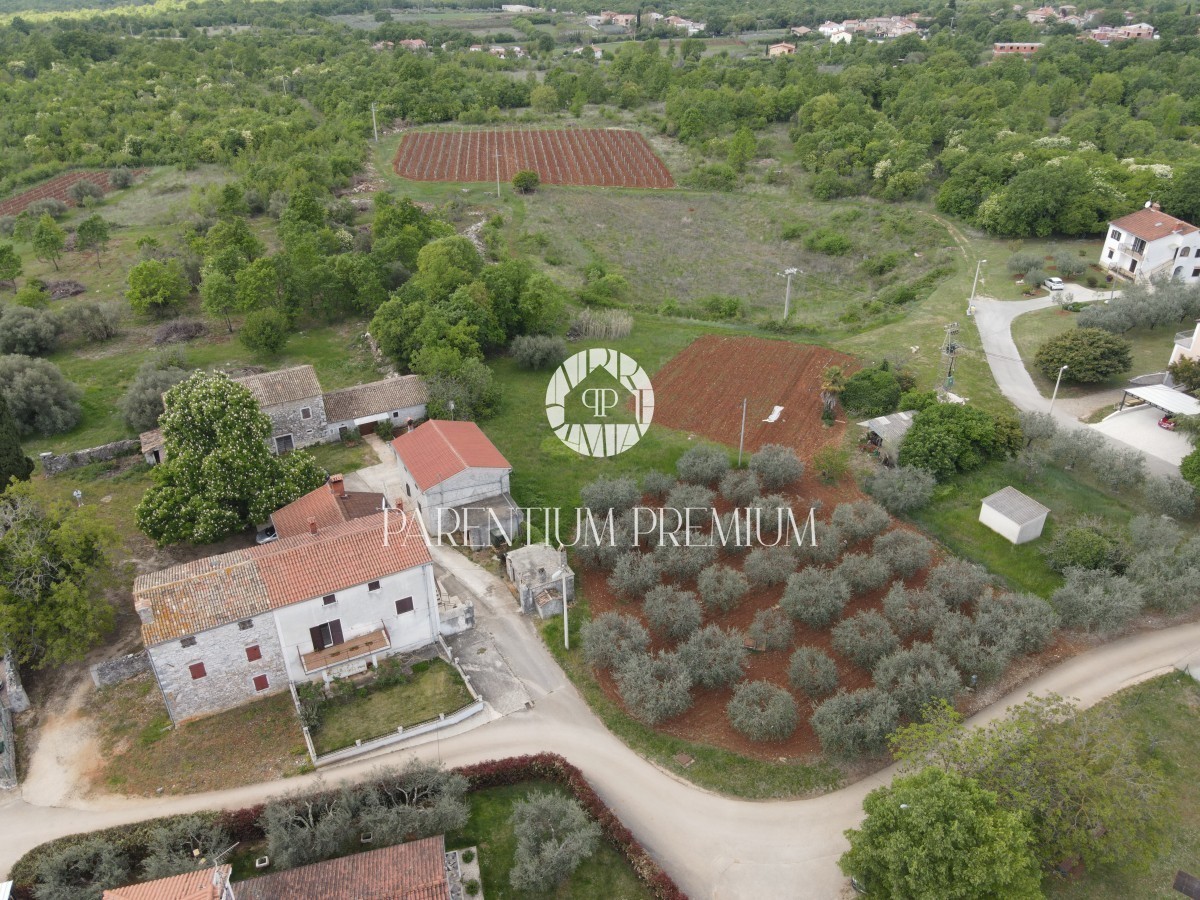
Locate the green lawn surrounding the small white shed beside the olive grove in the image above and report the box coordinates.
[912,462,1151,598]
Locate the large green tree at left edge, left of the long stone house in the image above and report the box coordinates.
[0,484,116,668]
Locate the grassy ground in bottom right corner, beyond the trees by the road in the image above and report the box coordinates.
[1044,672,1200,900]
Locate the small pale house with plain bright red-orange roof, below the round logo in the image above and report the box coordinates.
[391,419,522,547]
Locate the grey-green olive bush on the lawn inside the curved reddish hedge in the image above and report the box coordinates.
[509,792,600,893]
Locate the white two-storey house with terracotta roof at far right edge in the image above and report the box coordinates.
[1100,203,1200,283]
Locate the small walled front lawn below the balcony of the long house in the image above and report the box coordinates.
[312,659,472,755]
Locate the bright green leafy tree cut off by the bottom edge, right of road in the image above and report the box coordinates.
[838,768,1042,900]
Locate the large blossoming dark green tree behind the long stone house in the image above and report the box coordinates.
[136,372,325,545]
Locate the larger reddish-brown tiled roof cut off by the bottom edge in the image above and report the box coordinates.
[231,835,450,900]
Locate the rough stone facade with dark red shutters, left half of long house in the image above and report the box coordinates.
[150,613,288,725]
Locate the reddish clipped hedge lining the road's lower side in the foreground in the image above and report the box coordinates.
[8,754,686,900]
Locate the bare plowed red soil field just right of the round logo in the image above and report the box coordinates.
[653,335,857,460]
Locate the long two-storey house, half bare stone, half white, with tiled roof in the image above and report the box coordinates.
[133,513,440,724]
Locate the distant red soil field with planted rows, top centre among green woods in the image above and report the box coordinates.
[392,128,674,187]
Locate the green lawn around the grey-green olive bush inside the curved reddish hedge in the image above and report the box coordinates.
[446,781,650,900]
